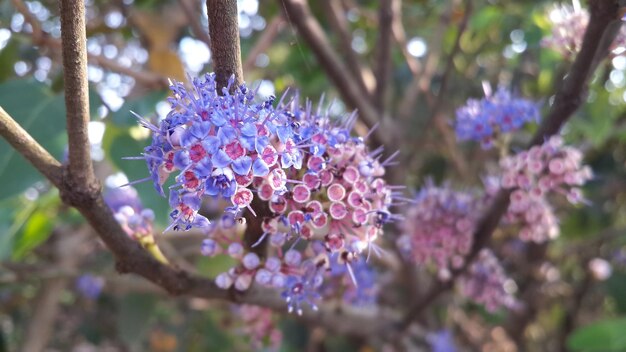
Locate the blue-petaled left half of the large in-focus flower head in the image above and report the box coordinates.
[139,74,278,230]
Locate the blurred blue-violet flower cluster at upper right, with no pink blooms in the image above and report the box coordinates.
[455,87,540,149]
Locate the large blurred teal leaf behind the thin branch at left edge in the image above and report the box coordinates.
[0,80,67,200]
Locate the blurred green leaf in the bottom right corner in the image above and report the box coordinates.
[567,317,626,352]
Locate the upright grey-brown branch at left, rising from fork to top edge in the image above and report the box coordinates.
[59,0,100,196]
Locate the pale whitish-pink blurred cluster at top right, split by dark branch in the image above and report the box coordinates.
[541,0,626,59]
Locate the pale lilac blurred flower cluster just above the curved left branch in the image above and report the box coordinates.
[104,186,154,240]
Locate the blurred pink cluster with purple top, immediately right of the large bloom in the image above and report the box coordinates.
[397,181,482,279]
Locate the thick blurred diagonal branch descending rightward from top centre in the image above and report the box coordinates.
[281,0,393,145]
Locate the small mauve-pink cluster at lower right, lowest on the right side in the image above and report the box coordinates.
[459,249,518,312]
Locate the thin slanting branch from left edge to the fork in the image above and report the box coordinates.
[0,106,63,188]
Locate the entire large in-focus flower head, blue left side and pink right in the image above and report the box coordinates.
[140,74,392,313]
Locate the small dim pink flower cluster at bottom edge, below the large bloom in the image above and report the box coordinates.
[234,304,283,351]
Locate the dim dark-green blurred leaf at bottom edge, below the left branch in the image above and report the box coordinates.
[116,293,157,350]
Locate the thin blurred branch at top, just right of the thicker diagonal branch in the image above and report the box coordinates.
[322,0,375,94]
